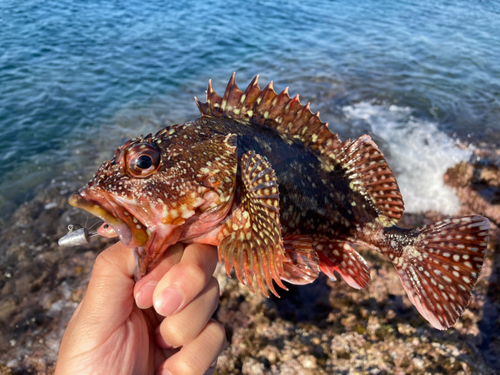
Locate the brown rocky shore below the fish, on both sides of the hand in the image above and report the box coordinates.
[0,150,500,375]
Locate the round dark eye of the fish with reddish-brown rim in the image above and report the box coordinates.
[125,143,161,178]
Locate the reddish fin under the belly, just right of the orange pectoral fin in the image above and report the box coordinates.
[281,235,320,285]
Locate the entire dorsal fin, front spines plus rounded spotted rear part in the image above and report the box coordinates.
[195,73,404,226]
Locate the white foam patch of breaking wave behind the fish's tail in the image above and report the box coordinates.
[343,102,473,215]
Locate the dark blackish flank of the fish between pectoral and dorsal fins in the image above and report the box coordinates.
[189,116,381,240]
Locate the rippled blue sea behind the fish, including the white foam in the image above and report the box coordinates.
[0,0,500,219]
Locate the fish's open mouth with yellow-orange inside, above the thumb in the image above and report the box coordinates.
[68,191,149,248]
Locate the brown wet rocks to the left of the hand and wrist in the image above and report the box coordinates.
[0,180,113,374]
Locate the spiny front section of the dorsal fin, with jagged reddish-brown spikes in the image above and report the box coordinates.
[195,73,340,154]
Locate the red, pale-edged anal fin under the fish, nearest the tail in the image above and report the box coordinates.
[316,240,370,289]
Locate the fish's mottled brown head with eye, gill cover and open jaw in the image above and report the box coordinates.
[69,124,236,278]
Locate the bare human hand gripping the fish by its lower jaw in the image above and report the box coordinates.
[56,242,226,375]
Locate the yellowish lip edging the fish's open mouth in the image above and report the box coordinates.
[68,189,140,247]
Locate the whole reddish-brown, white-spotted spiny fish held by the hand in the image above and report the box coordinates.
[69,73,490,330]
